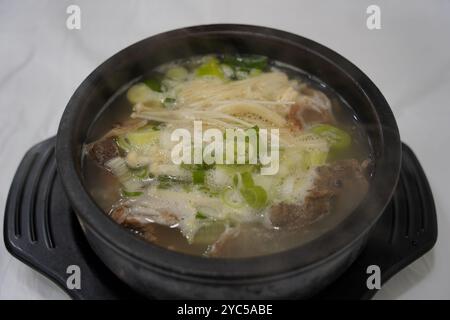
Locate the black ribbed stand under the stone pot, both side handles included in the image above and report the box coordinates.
[4,138,437,299]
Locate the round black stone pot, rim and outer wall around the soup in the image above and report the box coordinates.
[56,24,401,299]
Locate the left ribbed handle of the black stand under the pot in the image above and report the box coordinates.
[4,137,141,299]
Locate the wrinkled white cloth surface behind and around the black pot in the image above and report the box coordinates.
[0,0,450,299]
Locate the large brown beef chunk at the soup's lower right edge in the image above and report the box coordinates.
[269,159,368,229]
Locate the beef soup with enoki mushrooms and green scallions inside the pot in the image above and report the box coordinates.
[83,55,371,257]
